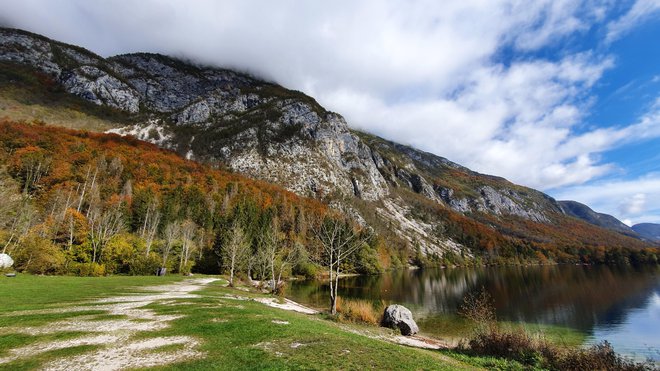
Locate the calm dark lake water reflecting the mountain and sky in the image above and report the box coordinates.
[287,266,660,362]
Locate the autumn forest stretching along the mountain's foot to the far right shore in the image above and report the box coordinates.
[0,120,657,282]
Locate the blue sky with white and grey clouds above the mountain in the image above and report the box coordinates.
[0,0,660,224]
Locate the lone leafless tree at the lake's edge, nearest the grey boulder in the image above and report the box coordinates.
[314,217,364,315]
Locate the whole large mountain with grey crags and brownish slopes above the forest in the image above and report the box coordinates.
[0,29,646,264]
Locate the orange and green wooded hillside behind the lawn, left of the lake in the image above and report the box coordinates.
[0,121,393,279]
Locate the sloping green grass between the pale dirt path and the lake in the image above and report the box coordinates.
[141,285,465,370]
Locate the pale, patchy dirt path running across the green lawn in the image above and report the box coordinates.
[0,278,216,370]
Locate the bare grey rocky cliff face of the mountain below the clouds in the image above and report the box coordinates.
[0,29,648,256]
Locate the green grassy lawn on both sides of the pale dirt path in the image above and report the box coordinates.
[0,275,484,370]
